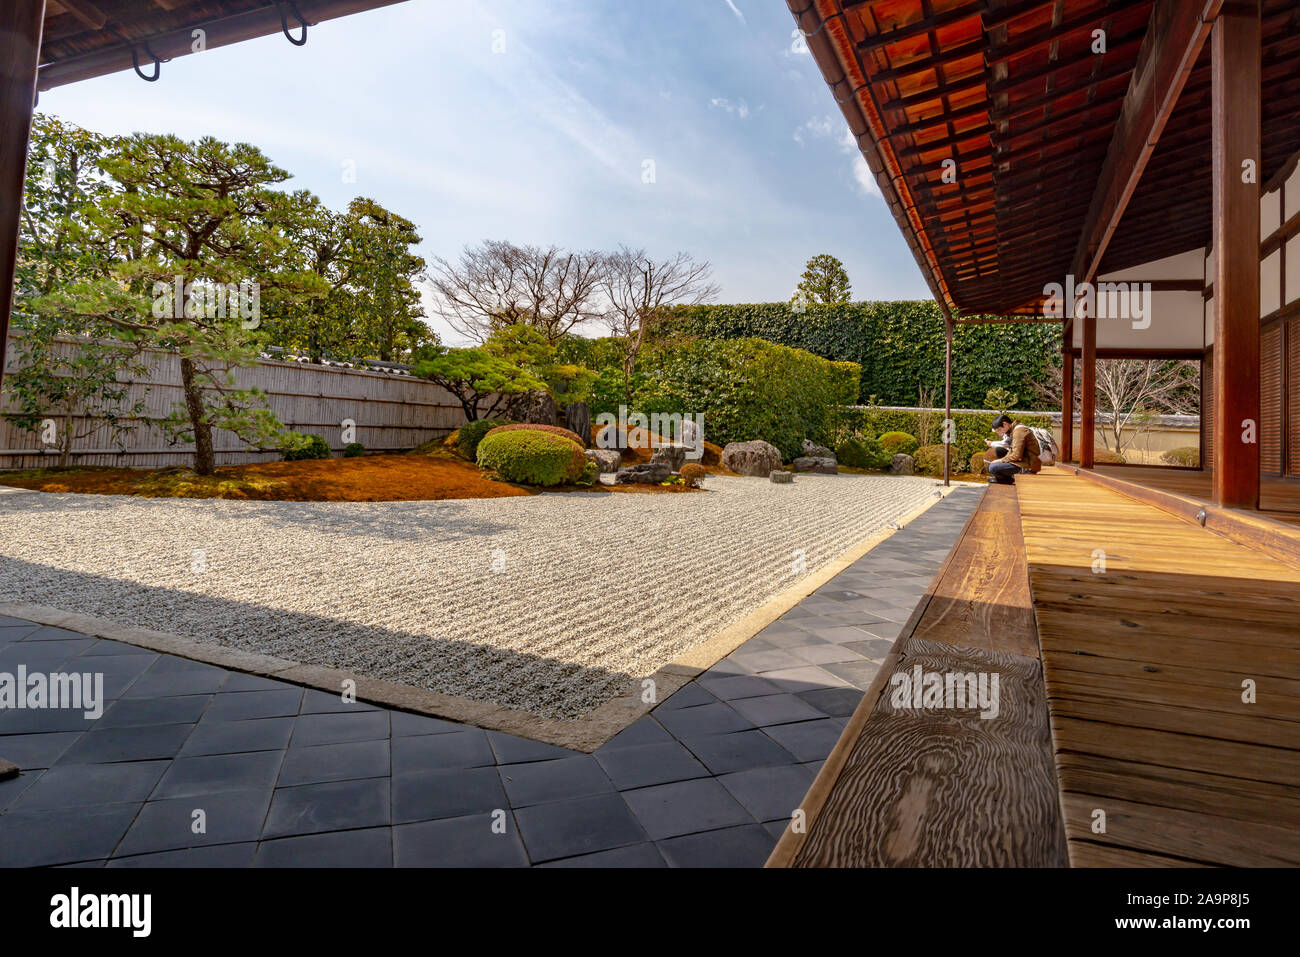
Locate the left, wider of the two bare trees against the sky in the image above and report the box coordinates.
[425,239,606,343]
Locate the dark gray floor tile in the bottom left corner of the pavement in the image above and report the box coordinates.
[0,802,140,867]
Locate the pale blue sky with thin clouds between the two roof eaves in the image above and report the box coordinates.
[40,0,930,342]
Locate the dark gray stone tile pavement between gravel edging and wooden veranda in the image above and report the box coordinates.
[0,488,980,867]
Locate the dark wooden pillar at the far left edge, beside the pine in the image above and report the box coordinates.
[0,0,46,395]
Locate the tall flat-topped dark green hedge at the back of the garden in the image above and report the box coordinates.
[675,300,1061,408]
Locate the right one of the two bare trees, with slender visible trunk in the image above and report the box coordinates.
[601,246,718,399]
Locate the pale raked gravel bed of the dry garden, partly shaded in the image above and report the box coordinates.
[0,475,937,718]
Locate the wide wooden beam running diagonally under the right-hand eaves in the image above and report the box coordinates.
[1070,0,1223,297]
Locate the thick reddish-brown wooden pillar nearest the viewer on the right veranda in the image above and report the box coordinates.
[1210,0,1261,508]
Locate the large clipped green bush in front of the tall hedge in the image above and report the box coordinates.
[603,338,852,459]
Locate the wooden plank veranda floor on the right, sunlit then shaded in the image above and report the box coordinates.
[1017,469,1300,866]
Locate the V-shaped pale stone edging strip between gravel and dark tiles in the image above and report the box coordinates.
[0,485,961,748]
